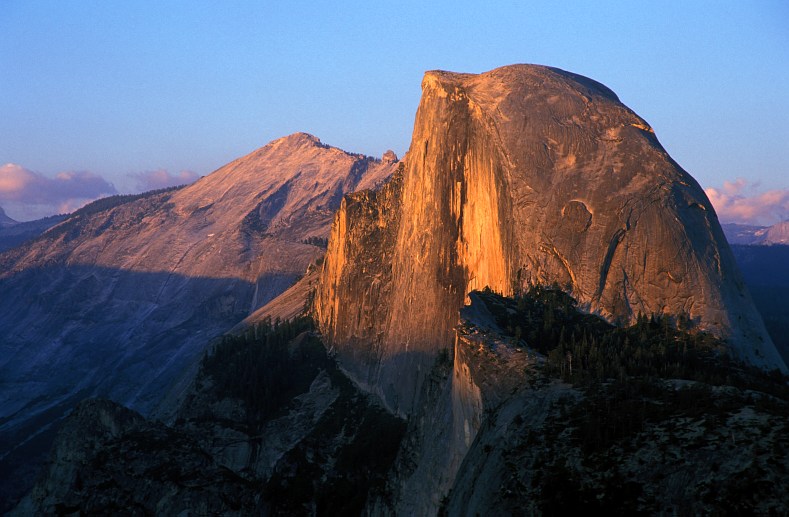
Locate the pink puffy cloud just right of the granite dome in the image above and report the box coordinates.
[705,178,789,225]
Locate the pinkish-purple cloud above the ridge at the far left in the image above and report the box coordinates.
[0,163,118,218]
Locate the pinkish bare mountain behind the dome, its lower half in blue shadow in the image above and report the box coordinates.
[0,133,396,508]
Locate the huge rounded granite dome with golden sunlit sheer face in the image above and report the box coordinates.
[316,65,786,413]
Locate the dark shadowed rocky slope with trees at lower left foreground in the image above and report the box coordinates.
[12,324,405,515]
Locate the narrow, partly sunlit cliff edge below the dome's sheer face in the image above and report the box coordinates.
[369,292,548,515]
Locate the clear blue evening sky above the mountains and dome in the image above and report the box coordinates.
[0,0,789,223]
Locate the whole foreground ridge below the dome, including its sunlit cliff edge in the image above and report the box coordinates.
[368,292,789,515]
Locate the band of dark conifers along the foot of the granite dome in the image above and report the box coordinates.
[484,285,789,397]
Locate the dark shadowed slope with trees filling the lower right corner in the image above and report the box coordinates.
[464,286,789,514]
